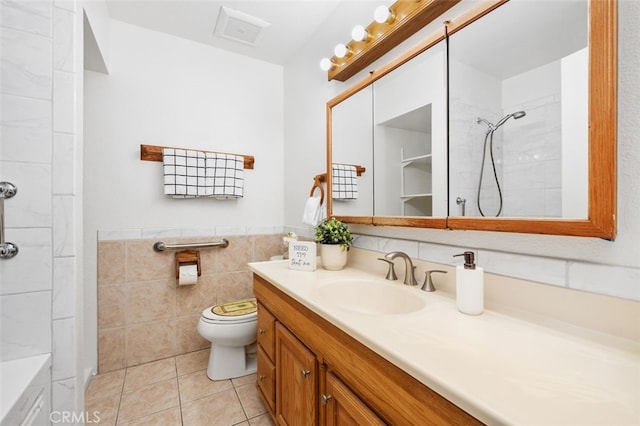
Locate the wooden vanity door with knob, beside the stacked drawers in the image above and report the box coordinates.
[276,322,318,426]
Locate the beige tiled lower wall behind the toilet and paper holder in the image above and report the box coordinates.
[98,233,284,373]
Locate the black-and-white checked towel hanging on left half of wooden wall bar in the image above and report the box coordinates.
[162,148,205,198]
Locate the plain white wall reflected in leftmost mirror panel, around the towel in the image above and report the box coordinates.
[331,86,374,216]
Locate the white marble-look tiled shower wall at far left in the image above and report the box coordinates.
[0,0,84,411]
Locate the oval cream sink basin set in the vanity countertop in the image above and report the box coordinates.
[316,279,426,315]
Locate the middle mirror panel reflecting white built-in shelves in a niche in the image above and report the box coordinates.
[373,42,446,217]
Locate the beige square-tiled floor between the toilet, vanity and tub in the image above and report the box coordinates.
[85,349,273,426]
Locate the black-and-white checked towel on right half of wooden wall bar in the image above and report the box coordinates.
[205,152,244,200]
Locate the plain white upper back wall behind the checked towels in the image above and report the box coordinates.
[84,20,285,372]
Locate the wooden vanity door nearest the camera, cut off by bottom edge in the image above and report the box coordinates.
[321,373,385,426]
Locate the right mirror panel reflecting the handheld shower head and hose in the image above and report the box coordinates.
[449,0,589,219]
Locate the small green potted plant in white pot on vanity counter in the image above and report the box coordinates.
[315,218,353,271]
